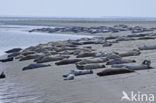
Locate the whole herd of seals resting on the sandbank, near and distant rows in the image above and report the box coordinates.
[0,25,156,80]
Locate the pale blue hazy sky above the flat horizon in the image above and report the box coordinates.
[0,0,156,18]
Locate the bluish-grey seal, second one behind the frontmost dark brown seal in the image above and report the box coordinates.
[106,59,136,65]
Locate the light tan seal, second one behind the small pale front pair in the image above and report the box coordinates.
[77,57,109,64]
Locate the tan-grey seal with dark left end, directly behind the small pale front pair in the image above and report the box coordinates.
[76,64,105,70]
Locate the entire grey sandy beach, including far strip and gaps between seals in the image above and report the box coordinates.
[0,21,156,103]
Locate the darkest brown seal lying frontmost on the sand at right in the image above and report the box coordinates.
[97,68,134,76]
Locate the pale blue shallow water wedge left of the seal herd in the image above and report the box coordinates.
[0,26,91,55]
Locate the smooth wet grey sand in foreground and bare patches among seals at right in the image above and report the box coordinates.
[0,20,156,103]
